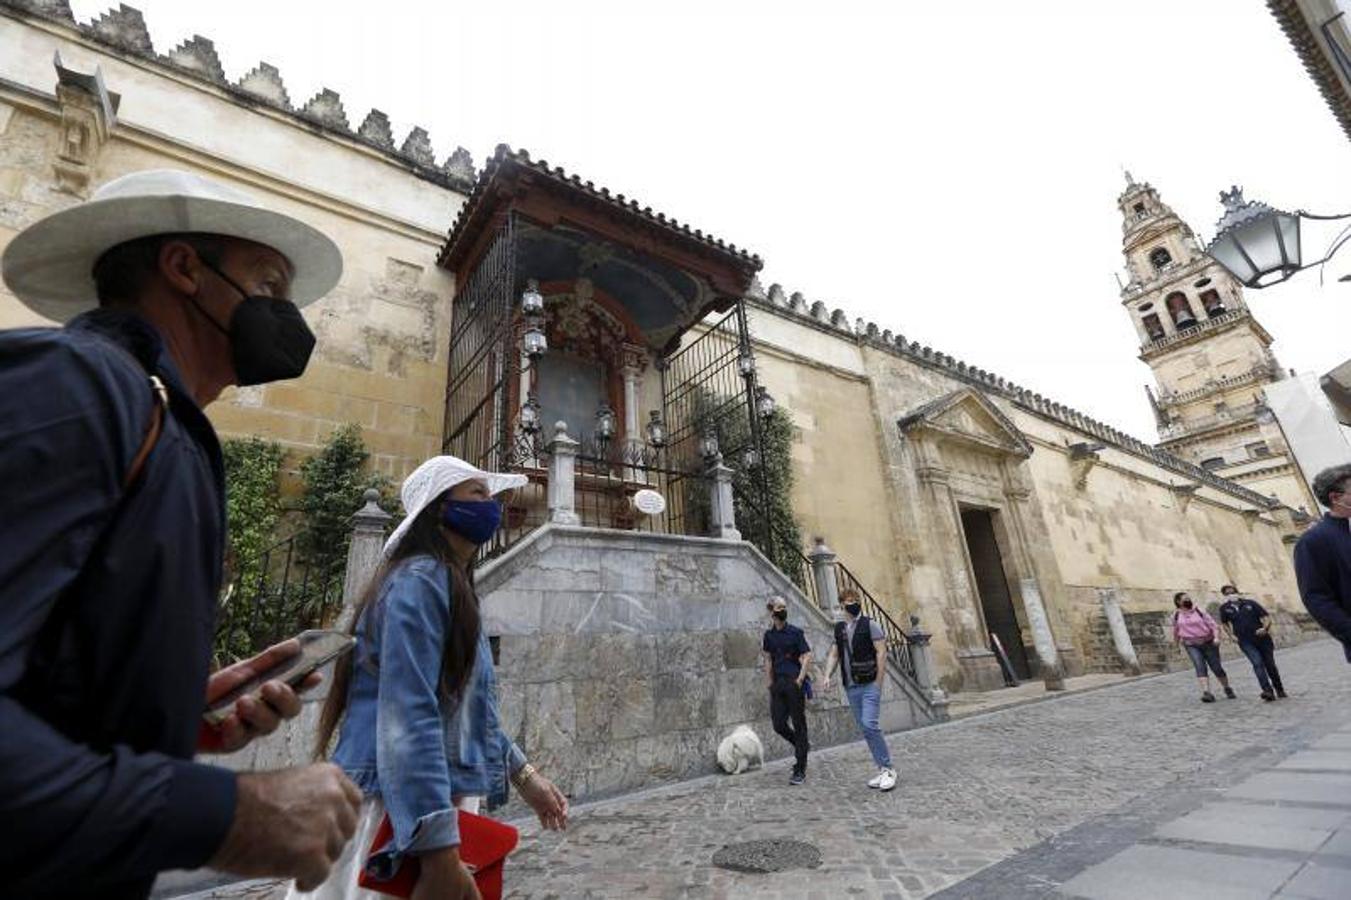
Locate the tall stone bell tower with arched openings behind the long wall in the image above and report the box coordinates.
[1116,173,1317,509]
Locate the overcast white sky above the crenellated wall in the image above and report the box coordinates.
[72,0,1351,439]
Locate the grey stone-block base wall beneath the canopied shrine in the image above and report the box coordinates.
[478,526,928,799]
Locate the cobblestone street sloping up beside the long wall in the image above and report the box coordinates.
[507,641,1351,900]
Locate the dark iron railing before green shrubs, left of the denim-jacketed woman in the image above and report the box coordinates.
[215,532,347,665]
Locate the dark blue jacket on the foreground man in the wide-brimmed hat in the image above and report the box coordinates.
[0,311,235,899]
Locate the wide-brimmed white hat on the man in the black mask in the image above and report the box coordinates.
[0,169,342,322]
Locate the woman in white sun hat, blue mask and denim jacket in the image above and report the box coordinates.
[303,457,567,900]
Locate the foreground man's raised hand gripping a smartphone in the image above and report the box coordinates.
[197,638,323,753]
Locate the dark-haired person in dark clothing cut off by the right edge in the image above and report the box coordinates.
[1294,465,1351,662]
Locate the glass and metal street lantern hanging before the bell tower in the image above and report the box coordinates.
[1205,185,1302,288]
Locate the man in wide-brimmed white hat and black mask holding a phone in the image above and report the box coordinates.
[0,170,361,899]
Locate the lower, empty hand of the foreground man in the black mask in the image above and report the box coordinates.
[207,762,361,891]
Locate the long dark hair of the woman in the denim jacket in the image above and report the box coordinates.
[315,492,480,759]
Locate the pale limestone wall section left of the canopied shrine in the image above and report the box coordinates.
[0,5,463,478]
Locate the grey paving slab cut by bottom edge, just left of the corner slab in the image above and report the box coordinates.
[1062,845,1301,900]
